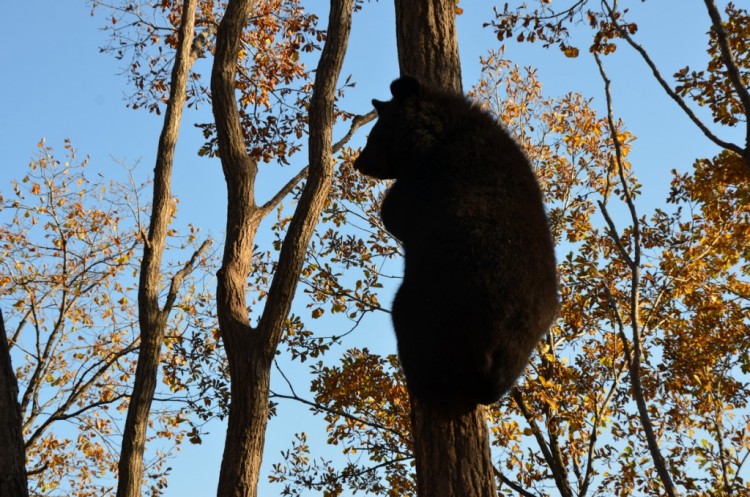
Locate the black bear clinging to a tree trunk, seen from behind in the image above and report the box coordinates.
[354,77,558,405]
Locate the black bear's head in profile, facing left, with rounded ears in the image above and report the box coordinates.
[354,76,425,179]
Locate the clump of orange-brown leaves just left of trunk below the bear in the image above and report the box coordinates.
[271,349,415,496]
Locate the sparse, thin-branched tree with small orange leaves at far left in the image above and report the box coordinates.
[0,141,149,496]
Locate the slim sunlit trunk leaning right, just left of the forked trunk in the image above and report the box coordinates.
[117,0,200,497]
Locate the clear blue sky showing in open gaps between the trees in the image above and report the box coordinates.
[0,0,741,497]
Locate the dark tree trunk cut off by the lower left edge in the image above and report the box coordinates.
[0,311,29,497]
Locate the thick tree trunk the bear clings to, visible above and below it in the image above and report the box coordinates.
[395,0,497,497]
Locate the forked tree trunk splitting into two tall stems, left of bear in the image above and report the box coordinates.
[211,0,353,497]
